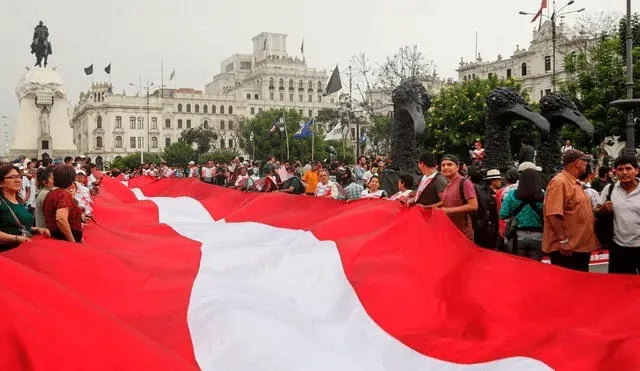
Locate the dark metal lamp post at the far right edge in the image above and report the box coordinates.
[611,0,640,156]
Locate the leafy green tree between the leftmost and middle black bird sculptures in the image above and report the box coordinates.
[424,76,532,159]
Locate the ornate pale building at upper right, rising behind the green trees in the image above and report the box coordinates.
[457,21,589,101]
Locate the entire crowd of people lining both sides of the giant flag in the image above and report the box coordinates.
[0,142,640,274]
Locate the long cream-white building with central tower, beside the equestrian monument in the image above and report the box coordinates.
[71,33,338,164]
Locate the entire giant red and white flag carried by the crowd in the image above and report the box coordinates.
[0,178,640,371]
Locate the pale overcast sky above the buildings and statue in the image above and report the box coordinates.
[0,0,640,121]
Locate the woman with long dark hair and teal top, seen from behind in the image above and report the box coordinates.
[500,169,544,261]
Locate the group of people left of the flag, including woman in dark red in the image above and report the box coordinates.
[0,156,101,251]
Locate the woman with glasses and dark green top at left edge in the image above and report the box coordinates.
[0,165,50,251]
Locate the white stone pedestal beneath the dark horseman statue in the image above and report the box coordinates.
[9,67,77,158]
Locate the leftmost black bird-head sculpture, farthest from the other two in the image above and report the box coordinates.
[380,80,431,195]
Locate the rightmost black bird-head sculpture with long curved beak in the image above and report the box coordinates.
[536,93,595,174]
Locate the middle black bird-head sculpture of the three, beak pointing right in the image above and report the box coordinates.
[484,88,549,173]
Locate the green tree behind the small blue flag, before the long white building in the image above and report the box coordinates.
[238,109,328,161]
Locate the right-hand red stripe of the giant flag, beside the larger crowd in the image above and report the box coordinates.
[129,178,640,370]
